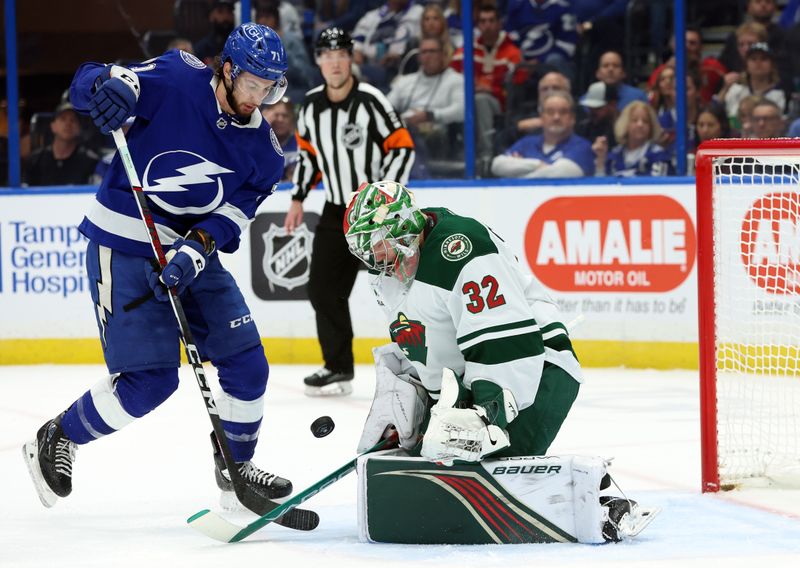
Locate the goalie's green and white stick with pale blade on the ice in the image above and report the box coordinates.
[186,435,397,542]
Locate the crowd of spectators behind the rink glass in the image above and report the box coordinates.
[10,0,800,185]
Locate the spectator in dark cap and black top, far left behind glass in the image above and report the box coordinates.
[23,102,97,186]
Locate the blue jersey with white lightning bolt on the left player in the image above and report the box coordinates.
[70,50,283,257]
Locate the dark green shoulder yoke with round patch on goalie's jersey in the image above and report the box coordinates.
[416,208,497,290]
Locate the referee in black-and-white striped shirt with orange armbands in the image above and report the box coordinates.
[284,27,414,396]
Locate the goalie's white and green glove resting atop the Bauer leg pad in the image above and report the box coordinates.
[421,368,519,465]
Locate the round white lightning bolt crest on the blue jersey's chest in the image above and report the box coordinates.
[142,150,233,215]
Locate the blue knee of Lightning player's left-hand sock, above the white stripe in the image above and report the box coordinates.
[114,367,178,418]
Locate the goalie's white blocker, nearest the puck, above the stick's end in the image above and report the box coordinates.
[358,343,428,453]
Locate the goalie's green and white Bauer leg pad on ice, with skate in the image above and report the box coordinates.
[357,450,659,544]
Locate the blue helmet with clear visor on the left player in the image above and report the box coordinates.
[222,23,288,104]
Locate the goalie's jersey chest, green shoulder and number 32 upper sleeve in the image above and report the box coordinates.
[384,209,535,393]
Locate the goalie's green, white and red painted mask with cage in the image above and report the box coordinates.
[344,181,425,303]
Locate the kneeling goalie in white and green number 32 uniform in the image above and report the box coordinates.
[344,181,657,544]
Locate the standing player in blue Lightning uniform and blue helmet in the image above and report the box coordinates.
[23,24,292,507]
